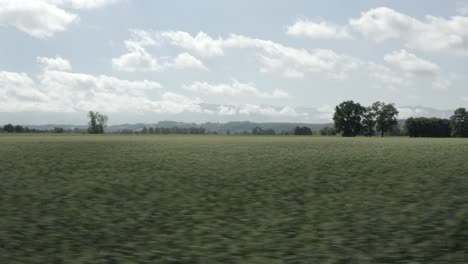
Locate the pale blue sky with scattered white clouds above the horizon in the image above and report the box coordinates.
[0,0,468,124]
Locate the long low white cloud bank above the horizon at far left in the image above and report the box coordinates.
[0,58,201,113]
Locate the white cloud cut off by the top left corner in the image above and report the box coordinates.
[0,0,79,38]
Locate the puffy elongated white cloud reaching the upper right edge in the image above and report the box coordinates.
[349,7,468,56]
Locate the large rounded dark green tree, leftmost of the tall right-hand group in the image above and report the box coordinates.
[333,101,365,137]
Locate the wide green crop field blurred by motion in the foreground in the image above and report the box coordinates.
[0,135,468,264]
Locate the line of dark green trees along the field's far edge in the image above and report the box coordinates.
[0,105,468,137]
